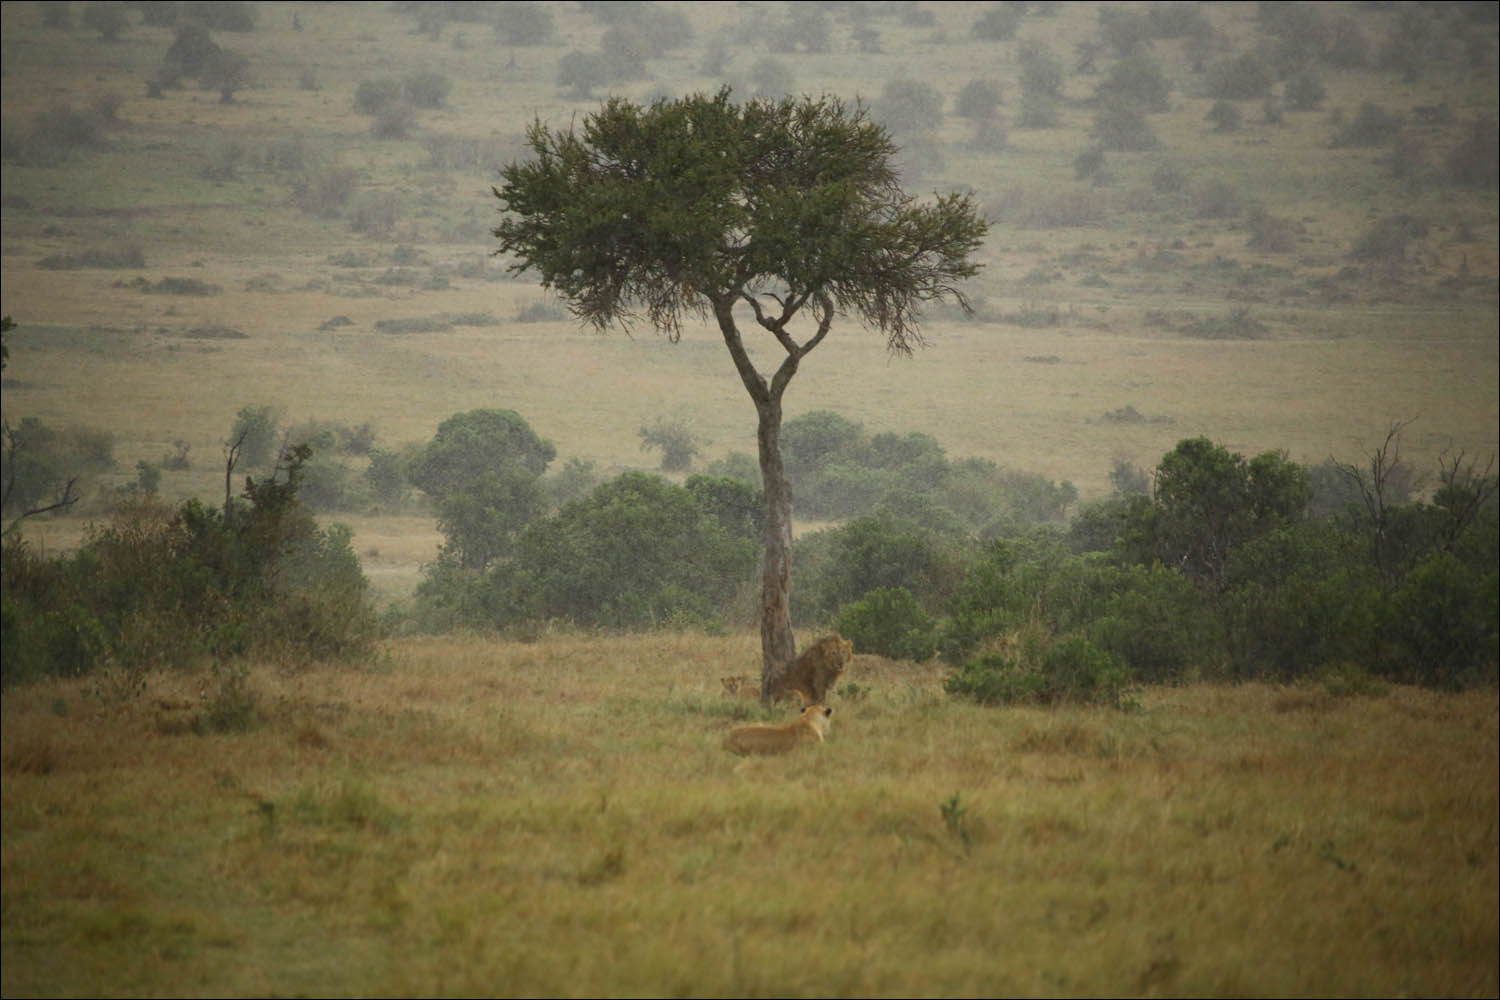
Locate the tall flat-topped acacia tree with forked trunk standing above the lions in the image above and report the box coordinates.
[494,88,987,696]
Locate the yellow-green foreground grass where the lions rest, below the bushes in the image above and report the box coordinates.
[0,634,1500,996]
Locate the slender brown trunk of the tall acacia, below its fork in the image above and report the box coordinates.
[756,396,797,702]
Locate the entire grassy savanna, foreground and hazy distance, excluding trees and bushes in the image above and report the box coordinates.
[0,3,1500,996]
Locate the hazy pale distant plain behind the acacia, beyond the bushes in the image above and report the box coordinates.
[0,3,1500,580]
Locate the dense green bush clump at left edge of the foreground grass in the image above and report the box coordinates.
[0,448,375,691]
